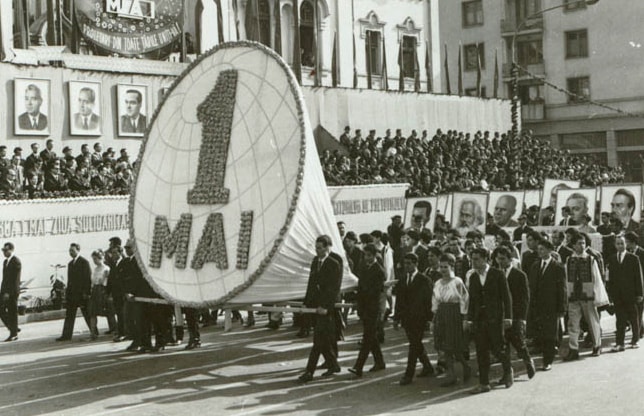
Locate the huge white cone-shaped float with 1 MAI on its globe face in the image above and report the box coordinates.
[129,42,357,330]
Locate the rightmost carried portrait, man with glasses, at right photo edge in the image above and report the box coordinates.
[599,184,642,233]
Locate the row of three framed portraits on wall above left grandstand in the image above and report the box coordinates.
[14,78,148,137]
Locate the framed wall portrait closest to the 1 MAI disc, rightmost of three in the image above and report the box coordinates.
[116,84,148,137]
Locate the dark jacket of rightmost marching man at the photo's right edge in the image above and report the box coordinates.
[607,253,642,304]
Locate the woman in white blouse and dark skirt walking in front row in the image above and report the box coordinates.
[432,253,471,387]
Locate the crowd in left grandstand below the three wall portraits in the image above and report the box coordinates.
[0,139,133,199]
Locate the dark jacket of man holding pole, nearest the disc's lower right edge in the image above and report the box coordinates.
[304,254,342,313]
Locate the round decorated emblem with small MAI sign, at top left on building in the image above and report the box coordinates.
[74,0,183,59]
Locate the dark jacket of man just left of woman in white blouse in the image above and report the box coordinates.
[396,272,434,328]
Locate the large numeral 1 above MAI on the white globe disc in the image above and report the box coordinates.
[188,69,238,205]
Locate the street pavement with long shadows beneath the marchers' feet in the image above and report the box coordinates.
[0,314,644,416]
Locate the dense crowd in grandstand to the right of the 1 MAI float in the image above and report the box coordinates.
[320,126,624,196]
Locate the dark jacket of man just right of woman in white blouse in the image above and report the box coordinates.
[467,267,512,322]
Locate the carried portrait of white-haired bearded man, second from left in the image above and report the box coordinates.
[452,192,488,237]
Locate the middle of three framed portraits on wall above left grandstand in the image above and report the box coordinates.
[69,81,103,136]
